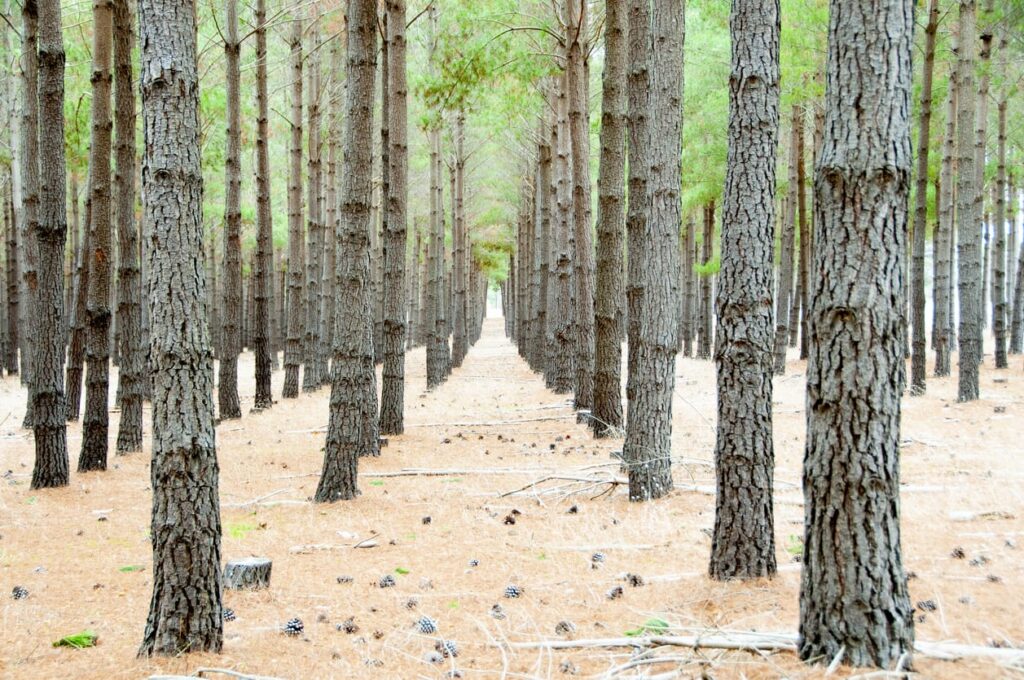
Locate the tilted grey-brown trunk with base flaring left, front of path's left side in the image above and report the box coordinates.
[313,0,380,503]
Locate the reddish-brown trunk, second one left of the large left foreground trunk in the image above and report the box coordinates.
[78,0,114,472]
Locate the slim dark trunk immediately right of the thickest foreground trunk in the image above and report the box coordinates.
[910,0,939,394]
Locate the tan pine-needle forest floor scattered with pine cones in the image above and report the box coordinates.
[0,318,1024,680]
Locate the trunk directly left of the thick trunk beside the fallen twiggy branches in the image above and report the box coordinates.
[591,0,629,437]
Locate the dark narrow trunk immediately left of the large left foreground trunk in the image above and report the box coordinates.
[114,0,145,454]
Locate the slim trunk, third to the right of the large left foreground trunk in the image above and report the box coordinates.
[282,18,309,399]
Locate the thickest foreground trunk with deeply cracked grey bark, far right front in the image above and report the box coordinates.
[798,0,913,669]
